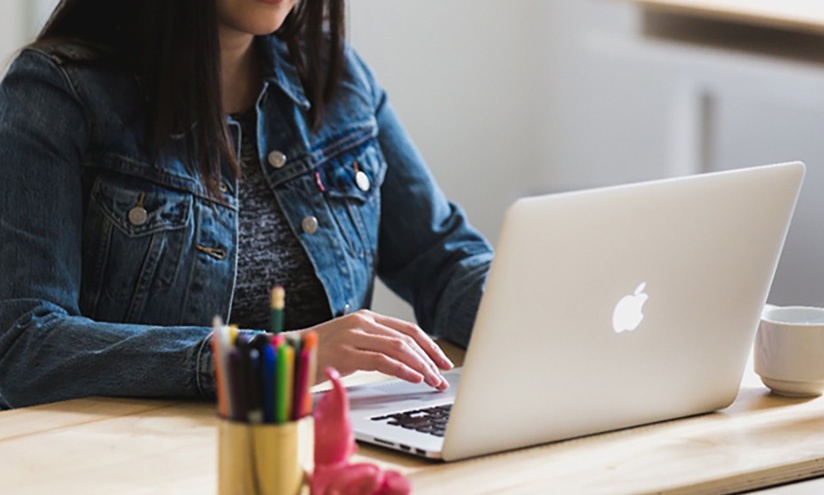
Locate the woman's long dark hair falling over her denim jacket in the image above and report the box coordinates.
[34,0,344,196]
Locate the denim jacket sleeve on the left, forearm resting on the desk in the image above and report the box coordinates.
[0,50,214,409]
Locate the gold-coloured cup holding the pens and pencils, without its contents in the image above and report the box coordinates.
[218,417,313,495]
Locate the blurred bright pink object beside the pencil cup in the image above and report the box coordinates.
[310,368,412,495]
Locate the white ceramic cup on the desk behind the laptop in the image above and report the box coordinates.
[754,306,824,397]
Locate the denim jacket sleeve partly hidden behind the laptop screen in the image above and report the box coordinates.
[353,48,493,347]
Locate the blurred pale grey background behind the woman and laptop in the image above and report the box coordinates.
[0,0,824,319]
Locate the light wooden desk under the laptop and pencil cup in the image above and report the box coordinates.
[0,344,824,495]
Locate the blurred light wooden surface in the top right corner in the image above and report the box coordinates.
[635,0,824,34]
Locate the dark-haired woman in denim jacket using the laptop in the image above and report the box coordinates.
[0,0,492,408]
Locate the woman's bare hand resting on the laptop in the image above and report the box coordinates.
[298,310,453,390]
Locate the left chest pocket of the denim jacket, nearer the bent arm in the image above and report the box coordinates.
[81,174,193,321]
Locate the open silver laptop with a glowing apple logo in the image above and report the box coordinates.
[342,162,804,461]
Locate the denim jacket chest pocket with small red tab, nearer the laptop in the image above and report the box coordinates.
[315,140,387,257]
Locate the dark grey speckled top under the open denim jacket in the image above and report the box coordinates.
[231,108,332,330]
